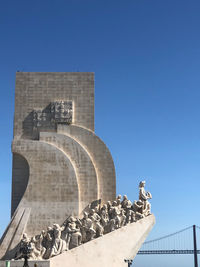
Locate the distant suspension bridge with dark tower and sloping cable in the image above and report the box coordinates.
[126,225,200,267]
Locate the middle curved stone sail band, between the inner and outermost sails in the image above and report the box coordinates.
[40,132,99,215]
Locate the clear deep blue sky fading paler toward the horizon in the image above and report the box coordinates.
[0,0,200,267]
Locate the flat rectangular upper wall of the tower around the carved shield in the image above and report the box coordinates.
[14,72,94,138]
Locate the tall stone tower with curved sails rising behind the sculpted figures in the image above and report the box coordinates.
[11,72,116,238]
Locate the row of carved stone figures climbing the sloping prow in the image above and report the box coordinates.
[15,181,152,259]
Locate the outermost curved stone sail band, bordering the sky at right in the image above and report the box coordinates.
[57,124,116,203]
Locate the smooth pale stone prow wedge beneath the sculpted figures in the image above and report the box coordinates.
[50,215,155,267]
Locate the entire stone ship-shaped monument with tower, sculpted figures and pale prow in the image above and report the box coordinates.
[0,72,154,267]
